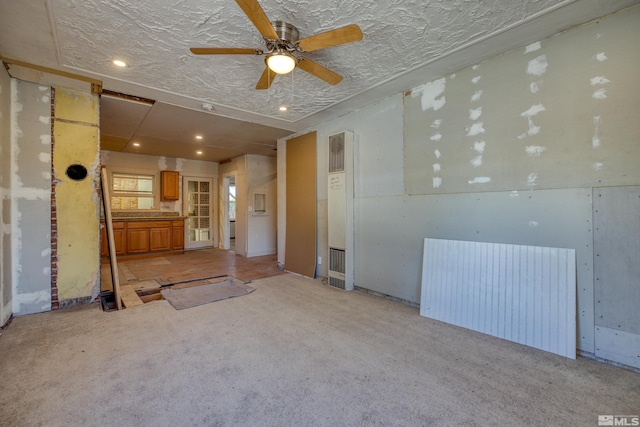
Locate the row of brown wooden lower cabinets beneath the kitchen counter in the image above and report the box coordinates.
[100,220,184,257]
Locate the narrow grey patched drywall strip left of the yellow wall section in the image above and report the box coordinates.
[9,79,51,314]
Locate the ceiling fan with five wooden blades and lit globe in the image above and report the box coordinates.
[190,0,362,89]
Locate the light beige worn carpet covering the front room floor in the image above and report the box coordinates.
[0,274,640,427]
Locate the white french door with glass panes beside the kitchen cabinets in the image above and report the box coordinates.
[184,176,213,249]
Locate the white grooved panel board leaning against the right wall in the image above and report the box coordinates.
[420,238,576,359]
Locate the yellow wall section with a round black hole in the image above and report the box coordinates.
[53,89,100,302]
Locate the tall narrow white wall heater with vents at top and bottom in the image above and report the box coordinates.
[327,131,355,291]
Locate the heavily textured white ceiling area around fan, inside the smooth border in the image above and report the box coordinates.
[51,0,559,121]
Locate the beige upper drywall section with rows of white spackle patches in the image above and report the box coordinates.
[404,7,640,194]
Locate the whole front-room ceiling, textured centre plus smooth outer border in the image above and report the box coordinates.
[0,0,638,160]
